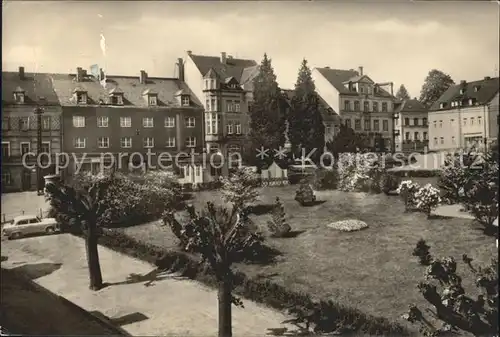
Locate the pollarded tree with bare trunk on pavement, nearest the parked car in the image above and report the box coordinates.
[45,178,111,290]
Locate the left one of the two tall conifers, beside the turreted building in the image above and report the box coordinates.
[249,54,286,166]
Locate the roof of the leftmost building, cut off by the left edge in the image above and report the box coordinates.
[2,71,59,105]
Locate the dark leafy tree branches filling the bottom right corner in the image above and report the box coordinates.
[403,243,498,336]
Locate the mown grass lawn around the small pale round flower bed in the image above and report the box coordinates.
[118,186,497,332]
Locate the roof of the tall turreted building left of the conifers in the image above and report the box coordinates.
[190,54,258,89]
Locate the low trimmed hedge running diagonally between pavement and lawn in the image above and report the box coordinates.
[94,230,407,336]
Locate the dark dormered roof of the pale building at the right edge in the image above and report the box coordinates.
[430,77,500,110]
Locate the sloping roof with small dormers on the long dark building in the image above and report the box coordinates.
[51,74,201,107]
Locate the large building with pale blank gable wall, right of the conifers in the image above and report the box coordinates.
[312,67,397,149]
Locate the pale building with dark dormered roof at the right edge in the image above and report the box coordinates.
[429,77,500,151]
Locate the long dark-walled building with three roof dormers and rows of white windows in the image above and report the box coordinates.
[52,68,204,183]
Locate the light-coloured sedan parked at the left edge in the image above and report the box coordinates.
[2,215,59,239]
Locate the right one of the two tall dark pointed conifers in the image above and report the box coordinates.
[288,59,325,163]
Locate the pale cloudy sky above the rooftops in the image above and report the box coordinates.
[2,0,500,97]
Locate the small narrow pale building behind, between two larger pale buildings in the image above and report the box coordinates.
[394,98,429,152]
